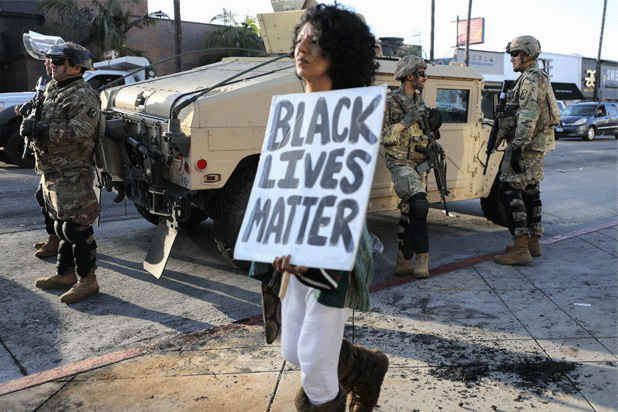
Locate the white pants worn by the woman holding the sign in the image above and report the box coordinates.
[281,275,352,405]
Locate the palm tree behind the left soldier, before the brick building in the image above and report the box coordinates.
[38,0,169,57]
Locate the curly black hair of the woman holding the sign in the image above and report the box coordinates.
[292,3,378,90]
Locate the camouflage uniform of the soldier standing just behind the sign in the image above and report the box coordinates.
[382,87,429,259]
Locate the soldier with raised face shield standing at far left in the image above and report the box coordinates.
[21,43,104,303]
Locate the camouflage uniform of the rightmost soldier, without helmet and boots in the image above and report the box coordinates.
[500,63,560,238]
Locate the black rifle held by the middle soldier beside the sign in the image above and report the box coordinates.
[415,109,450,216]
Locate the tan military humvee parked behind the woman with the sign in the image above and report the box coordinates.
[95,3,502,276]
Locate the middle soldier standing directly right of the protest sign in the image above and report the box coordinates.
[382,56,436,278]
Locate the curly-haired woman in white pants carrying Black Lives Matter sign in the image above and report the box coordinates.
[244,4,388,412]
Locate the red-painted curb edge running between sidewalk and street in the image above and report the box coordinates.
[0,221,618,396]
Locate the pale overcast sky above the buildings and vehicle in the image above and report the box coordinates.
[148,0,618,61]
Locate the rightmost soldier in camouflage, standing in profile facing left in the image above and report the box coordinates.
[494,36,560,265]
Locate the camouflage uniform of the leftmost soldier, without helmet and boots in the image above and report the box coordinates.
[33,76,104,277]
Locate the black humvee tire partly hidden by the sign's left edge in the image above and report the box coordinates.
[211,165,257,270]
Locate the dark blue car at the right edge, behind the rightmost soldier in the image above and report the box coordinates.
[555,102,618,141]
